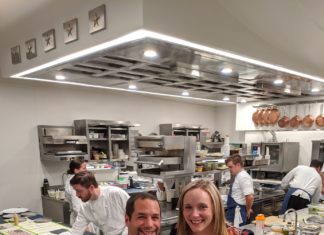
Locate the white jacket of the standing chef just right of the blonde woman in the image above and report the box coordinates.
[231,170,254,205]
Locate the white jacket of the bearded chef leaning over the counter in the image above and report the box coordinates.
[71,186,129,235]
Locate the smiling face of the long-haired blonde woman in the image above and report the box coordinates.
[183,188,214,234]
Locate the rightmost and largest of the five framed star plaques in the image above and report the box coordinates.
[89,5,106,33]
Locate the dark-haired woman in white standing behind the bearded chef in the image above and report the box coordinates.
[65,159,87,225]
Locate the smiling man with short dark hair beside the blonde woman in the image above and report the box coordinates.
[125,193,161,235]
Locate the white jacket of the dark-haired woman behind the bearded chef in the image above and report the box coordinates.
[64,175,82,226]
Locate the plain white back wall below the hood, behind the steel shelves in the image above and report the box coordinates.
[0,79,223,212]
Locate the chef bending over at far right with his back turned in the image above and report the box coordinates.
[280,160,323,214]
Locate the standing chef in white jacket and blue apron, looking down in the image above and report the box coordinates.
[226,154,254,226]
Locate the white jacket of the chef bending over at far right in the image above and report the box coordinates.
[281,165,322,203]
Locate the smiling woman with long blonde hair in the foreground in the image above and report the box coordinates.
[178,180,229,235]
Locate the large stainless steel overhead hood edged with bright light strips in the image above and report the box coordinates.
[12,30,324,103]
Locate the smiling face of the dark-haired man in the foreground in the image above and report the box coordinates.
[125,199,161,235]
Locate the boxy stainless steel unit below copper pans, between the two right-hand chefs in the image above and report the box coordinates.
[251,142,299,172]
